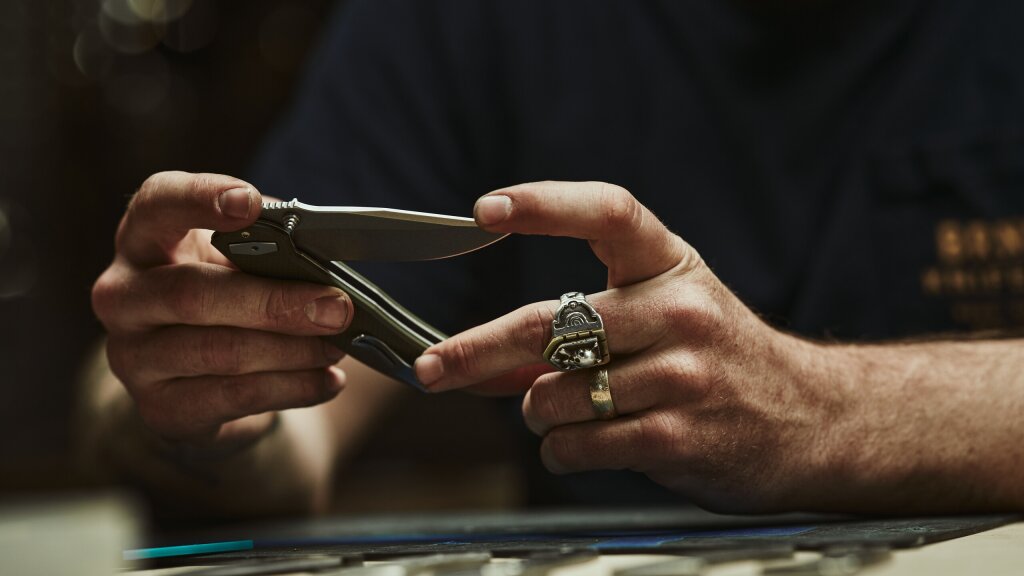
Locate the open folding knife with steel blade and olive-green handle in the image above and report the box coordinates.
[212,200,506,390]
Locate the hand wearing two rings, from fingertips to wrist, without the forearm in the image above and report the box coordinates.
[416,182,845,510]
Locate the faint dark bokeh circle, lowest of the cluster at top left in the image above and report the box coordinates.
[103,52,170,116]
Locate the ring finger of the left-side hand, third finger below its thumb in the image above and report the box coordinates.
[133,366,345,440]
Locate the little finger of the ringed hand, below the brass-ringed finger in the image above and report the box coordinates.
[541,411,686,474]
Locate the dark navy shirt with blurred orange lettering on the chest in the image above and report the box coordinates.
[252,0,1024,502]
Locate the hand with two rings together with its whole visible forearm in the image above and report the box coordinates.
[416,182,1024,513]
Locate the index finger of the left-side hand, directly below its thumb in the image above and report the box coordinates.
[93,262,352,335]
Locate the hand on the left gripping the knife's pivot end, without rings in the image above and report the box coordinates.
[92,172,352,448]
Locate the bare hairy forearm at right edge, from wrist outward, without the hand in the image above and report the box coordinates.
[819,340,1024,513]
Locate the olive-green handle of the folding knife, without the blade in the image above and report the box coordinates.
[211,219,445,392]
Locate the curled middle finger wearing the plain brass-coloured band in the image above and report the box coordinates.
[522,351,699,436]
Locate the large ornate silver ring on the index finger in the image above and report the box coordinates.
[544,292,611,371]
